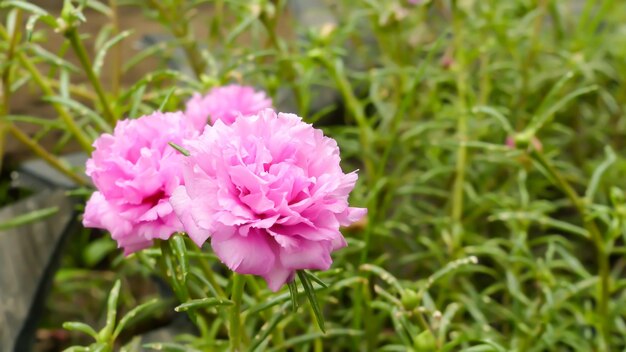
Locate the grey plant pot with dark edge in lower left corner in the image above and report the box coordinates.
[0,190,78,351]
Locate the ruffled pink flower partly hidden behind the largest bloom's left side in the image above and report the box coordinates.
[83,112,198,254]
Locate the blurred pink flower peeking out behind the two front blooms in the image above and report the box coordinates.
[185,84,272,132]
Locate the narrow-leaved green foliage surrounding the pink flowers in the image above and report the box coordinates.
[0,0,626,351]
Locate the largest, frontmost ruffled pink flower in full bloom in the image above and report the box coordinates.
[170,109,367,291]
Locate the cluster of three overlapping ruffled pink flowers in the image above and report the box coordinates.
[83,85,366,291]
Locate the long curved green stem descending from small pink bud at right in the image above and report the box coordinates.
[530,149,611,351]
